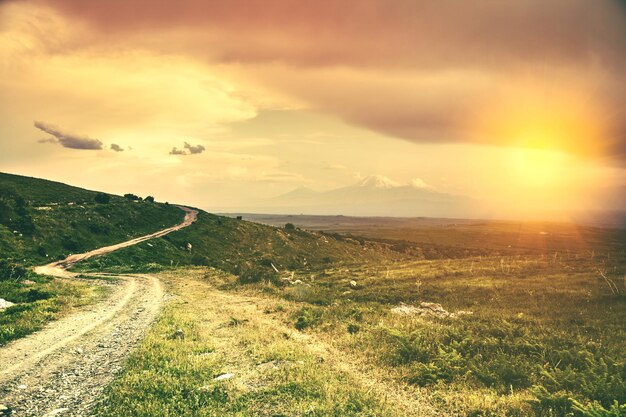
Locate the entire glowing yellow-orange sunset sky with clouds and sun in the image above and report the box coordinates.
[0,0,626,218]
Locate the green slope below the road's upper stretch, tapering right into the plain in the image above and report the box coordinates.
[79,212,400,281]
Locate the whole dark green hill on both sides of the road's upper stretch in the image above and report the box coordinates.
[0,174,399,276]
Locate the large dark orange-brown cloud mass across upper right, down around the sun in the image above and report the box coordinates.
[29,0,626,163]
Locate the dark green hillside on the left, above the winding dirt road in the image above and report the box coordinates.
[0,173,184,265]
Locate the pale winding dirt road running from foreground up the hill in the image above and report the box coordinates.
[0,206,198,416]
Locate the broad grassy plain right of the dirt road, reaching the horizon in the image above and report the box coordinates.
[94,216,626,416]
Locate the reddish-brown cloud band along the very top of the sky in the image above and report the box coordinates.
[31,0,626,67]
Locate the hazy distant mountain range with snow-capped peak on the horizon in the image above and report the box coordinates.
[254,175,476,217]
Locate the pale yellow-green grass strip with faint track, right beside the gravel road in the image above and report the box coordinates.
[95,270,397,417]
